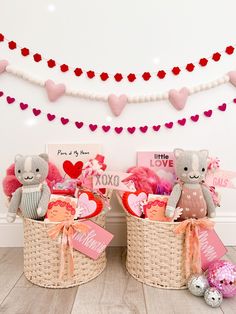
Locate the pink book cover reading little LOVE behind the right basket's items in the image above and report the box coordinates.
[137,152,176,185]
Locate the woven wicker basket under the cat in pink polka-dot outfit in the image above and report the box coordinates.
[126,214,186,289]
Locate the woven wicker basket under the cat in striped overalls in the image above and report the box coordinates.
[24,214,106,288]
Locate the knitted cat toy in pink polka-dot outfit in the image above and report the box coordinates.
[166,149,215,220]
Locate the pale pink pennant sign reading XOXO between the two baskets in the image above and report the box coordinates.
[93,171,136,192]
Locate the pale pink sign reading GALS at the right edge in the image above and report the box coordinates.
[206,169,236,189]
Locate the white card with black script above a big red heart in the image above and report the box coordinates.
[47,144,102,179]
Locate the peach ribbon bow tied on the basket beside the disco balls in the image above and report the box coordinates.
[174,218,214,278]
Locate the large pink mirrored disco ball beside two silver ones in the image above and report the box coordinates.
[207,260,236,298]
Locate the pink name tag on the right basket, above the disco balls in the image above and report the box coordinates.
[199,229,227,271]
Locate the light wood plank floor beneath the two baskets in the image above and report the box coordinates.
[0,248,236,314]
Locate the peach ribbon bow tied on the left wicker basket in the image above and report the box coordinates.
[48,220,89,280]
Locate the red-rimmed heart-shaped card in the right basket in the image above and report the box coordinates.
[122,191,148,217]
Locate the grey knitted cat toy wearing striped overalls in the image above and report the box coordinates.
[7,154,50,222]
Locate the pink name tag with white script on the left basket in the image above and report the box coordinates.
[72,220,113,260]
